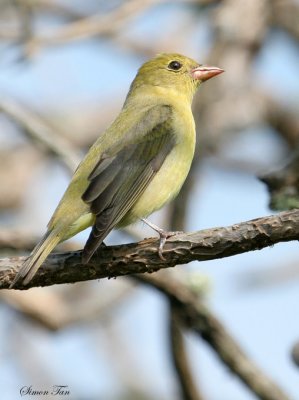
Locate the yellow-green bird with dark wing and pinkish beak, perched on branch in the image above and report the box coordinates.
[11,54,223,287]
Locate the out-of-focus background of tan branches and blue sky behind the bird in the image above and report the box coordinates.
[0,0,299,400]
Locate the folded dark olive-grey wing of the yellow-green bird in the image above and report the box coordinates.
[82,106,175,263]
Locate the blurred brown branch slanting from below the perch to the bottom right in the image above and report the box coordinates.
[136,271,290,400]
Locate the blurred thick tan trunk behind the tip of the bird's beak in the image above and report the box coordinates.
[194,0,299,157]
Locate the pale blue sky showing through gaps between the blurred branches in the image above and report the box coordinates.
[0,3,299,400]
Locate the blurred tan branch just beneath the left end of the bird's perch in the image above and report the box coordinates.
[0,280,135,331]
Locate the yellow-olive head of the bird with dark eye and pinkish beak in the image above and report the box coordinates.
[130,53,224,100]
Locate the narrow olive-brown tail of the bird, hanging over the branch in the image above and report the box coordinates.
[10,229,61,289]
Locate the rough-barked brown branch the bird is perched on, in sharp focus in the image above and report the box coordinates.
[0,210,299,289]
